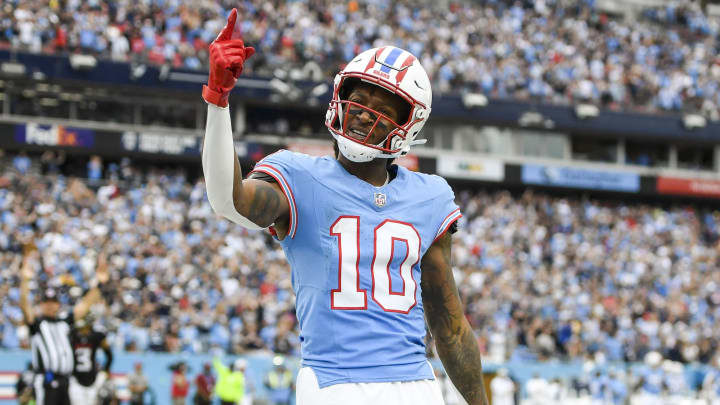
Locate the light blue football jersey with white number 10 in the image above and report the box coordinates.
[254,151,461,387]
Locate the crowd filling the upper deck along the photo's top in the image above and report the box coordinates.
[0,0,720,119]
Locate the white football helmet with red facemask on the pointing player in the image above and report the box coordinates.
[325,46,432,162]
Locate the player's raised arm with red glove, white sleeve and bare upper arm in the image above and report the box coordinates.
[202,9,290,229]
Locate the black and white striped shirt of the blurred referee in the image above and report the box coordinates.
[30,315,75,376]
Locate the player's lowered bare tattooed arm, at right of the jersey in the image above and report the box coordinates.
[420,232,488,405]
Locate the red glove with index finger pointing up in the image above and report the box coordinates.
[203,9,255,107]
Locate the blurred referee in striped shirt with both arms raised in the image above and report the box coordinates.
[20,249,108,405]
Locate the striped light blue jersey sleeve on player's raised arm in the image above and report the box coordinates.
[248,150,299,238]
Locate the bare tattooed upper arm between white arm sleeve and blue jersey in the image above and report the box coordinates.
[233,161,290,231]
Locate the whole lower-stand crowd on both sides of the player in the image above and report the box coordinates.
[0,152,720,372]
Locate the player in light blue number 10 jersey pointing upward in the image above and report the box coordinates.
[202,10,488,405]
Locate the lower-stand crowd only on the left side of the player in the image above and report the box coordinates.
[0,152,298,354]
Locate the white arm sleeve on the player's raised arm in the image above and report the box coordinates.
[202,103,262,229]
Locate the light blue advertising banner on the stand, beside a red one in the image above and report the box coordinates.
[522,165,640,192]
